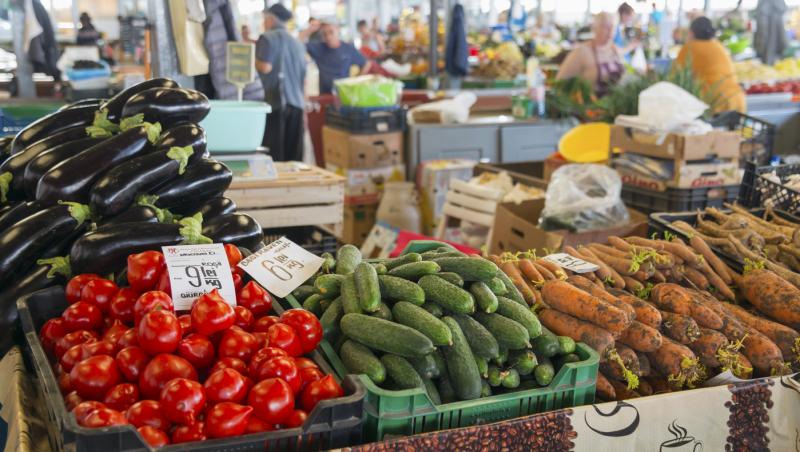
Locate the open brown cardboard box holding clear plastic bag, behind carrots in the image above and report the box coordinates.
[489,199,647,254]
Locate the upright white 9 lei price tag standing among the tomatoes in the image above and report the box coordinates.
[161,243,236,311]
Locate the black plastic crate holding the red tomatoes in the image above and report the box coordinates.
[17,286,366,452]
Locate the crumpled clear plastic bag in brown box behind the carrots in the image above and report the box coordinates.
[539,164,630,232]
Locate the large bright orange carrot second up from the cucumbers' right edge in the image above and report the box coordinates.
[542,281,631,334]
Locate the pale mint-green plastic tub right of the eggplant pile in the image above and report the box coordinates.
[200,100,272,152]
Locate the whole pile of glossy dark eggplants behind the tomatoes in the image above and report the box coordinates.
[0,78,263,356]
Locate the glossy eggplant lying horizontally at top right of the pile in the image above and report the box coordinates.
[122,88,211,129]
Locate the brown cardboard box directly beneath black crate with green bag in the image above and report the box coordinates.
[322,126,403,169]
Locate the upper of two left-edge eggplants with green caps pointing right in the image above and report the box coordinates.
[0,203,89,284]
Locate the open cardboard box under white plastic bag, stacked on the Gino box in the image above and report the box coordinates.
[611,125,741,160]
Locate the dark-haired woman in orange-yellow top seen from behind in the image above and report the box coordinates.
[675,17,747,113]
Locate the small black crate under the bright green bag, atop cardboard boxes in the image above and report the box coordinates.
[325,105,406,134]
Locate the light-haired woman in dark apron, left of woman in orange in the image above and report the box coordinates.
[556,13,625,96]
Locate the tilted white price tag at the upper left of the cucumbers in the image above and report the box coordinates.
[239,237,325,298]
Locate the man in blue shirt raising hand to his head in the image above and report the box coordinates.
[306,23,367,94]
